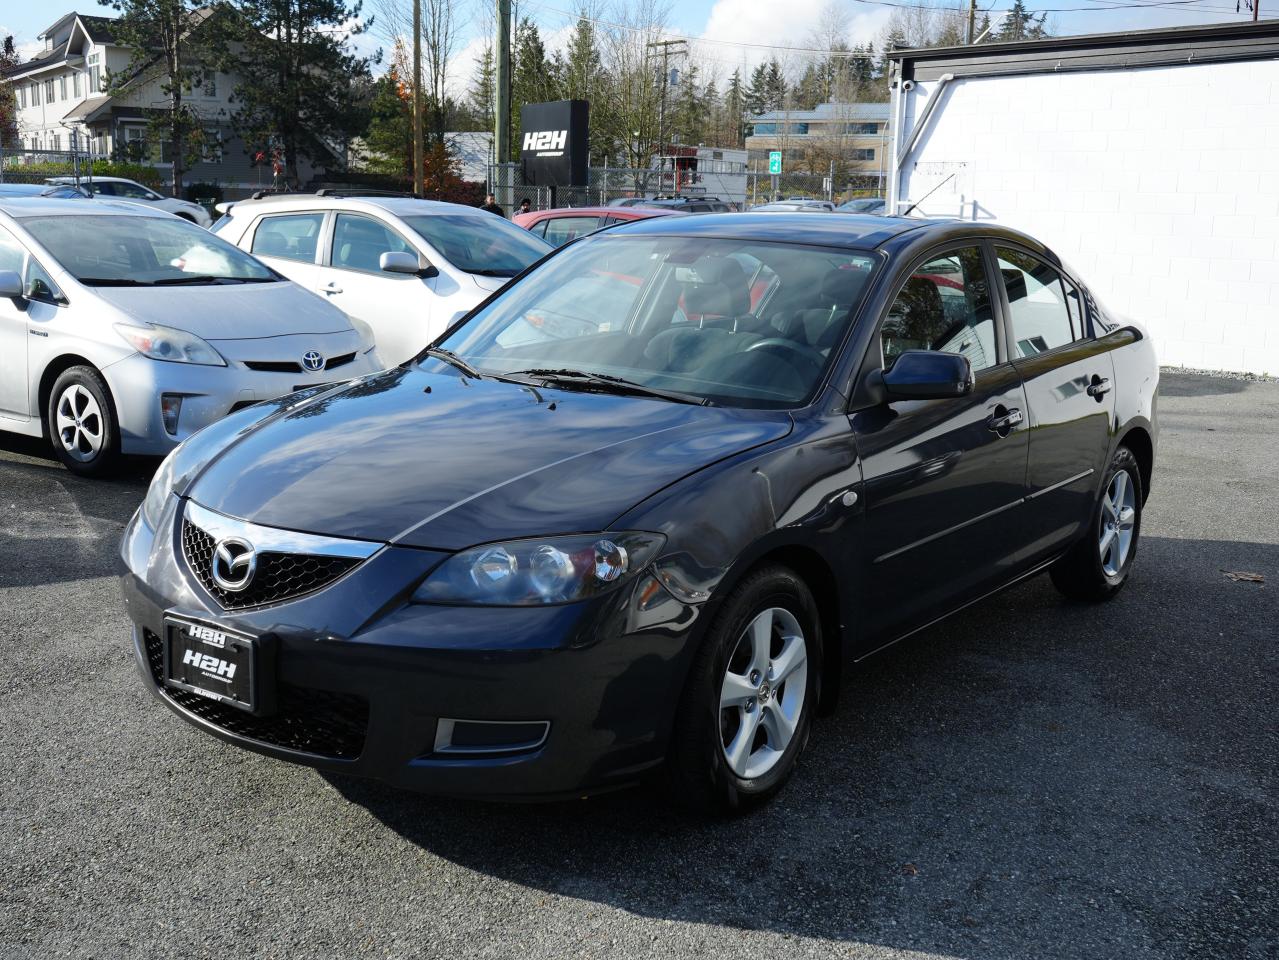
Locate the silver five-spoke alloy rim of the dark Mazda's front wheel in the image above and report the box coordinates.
[720,607,808,780]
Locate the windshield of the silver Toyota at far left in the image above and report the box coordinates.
[22,215,279,286]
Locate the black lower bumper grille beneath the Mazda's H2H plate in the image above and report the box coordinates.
[143,630,368,759]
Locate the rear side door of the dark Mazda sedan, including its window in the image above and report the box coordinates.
[994,243,1115,556]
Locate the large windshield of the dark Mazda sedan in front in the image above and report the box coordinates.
[440,234,876,408]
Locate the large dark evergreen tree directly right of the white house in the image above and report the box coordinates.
[233,0,380,183]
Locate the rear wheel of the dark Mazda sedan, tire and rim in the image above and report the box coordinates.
[1049,446,1142,600]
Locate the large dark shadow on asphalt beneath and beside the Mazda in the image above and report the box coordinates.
[329,537,1279,957]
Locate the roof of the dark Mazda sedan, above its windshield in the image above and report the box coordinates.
[596,212,954,249]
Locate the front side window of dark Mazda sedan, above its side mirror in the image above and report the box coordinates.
[880,247,998,371]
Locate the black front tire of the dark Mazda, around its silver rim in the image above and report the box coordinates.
[666,566,822,816]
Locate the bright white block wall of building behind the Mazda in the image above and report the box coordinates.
[899,60,1279,375]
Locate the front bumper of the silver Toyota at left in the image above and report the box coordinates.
[102,335,381,456]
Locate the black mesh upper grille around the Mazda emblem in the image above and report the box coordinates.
[182,519,359,610]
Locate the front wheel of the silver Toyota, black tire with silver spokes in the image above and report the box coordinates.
[45,367,120,477]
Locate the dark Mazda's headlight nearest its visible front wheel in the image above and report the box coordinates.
[413,532,666,606]
